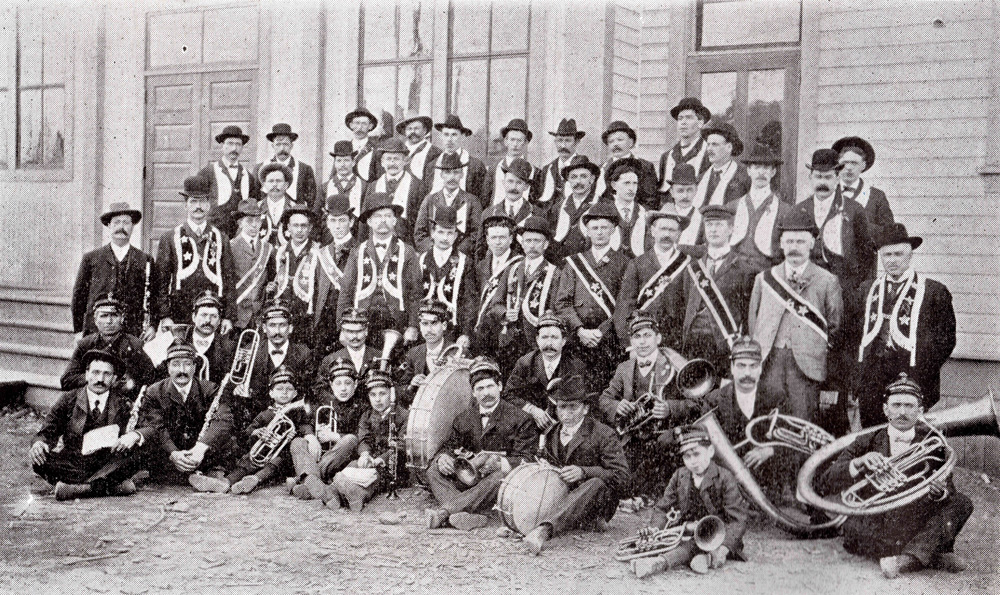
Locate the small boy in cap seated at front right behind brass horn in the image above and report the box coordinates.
[630,426,750,578]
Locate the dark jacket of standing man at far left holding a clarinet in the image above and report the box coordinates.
[72,244,160,337]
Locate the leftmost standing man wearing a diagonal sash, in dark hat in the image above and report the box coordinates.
[229,200,275,329]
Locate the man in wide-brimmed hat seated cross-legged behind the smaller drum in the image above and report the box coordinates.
[524,376,629,555]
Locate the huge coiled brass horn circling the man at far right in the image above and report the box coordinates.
[797,389,1000,516]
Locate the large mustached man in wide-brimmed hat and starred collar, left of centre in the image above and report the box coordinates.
[337,192,423,343]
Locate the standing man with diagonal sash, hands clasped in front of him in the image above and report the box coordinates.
[556,202,628,392]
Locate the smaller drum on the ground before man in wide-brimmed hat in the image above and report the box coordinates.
[497,462,569,535]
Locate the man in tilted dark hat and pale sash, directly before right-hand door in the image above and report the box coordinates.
[694,121,750,207]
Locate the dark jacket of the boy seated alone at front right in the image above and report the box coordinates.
[650,462,750,560]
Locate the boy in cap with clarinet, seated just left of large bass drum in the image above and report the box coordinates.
[328,369,407,511]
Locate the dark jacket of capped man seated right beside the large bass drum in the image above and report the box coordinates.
[439,399,538,467]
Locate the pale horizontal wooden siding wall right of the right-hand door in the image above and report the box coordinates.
[801,0,1000,361]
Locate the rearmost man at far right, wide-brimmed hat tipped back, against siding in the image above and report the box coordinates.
[831,136,895,242]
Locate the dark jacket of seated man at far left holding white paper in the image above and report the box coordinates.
[32,386,131,454]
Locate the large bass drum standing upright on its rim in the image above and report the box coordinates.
[406,360,472,481]
